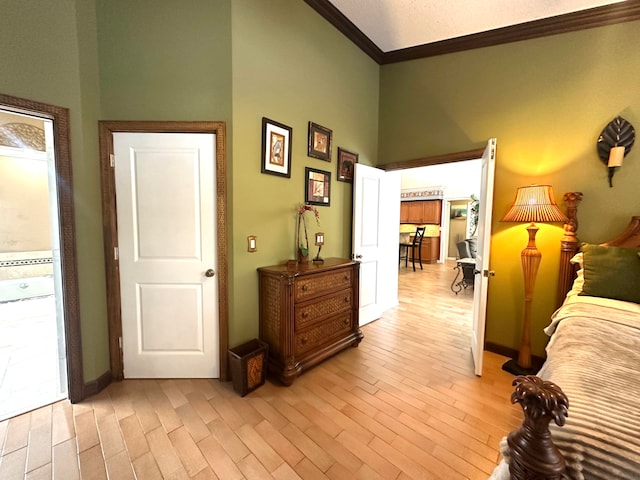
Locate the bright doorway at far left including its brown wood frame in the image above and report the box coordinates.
[0,95,83,420]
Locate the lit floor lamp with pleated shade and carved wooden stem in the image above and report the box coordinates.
[502,185,567,375]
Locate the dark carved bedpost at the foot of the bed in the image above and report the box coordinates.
[507,375,569,480]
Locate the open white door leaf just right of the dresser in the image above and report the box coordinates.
[353,163,400,325]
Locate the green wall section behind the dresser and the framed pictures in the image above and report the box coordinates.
[230,0,379,345]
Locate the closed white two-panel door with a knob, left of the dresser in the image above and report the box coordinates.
[113,133,220,378]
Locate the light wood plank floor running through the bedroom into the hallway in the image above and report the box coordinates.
[0,264,521,480]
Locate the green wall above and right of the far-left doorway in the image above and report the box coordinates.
[0,0,109,379]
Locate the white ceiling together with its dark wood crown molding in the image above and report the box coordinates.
[305,0,640,64]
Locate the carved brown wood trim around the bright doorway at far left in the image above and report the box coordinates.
[0,94,85,403]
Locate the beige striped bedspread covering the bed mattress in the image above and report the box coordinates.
[491,296,640,480]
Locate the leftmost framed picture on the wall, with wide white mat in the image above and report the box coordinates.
[260,117,291,178]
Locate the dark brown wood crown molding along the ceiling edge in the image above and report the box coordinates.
[305,0,640,65]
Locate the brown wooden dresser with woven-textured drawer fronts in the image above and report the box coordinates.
[258,258,363,385]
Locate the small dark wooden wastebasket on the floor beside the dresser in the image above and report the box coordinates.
[229,338,269,397]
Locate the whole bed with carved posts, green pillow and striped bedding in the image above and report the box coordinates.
[491,194,640,480]
